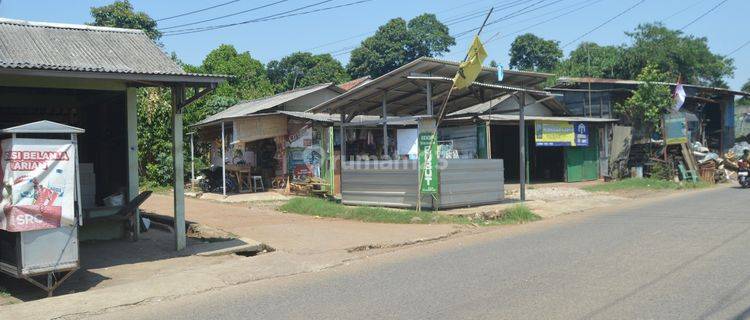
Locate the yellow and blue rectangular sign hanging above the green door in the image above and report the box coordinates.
[534,120,589,147]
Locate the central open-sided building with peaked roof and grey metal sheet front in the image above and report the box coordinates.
[310,58,612,208]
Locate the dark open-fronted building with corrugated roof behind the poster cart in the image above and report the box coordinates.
[0,19,224,250]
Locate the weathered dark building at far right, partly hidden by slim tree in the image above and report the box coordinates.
[548,77,750,176]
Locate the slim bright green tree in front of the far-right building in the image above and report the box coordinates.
[615,65,674,137]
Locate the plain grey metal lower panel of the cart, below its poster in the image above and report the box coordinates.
[21,226,78,275]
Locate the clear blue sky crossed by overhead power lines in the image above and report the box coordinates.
[0,0,750,89]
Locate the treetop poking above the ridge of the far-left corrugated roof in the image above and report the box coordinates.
[89,0,161,40]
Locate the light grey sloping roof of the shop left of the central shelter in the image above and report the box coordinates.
[196,82,341,125]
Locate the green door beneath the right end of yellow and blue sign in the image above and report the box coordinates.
[565,130,599,182]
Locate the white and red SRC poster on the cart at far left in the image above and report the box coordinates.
[0,139,76,232]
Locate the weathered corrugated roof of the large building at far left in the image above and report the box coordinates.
[0,18,212,76]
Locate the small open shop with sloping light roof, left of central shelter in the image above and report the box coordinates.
[194,82,388,194]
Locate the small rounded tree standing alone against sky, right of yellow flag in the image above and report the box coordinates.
[510,33,563,72]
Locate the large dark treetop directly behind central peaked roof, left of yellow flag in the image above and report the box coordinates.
[346,13,456,78]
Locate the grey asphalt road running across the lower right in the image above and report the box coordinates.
[94,187,750,319]
